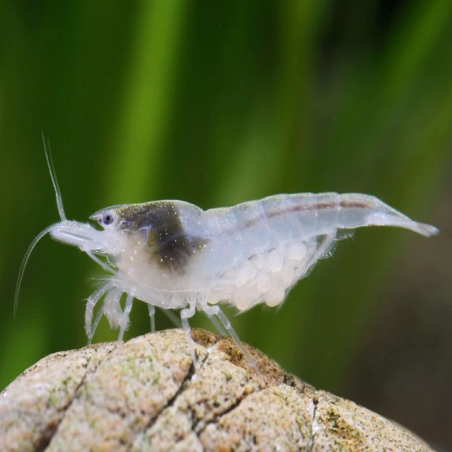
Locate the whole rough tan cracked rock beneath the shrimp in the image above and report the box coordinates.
[0,330,438,452]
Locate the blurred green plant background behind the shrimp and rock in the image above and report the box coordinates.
[0,0,452,447]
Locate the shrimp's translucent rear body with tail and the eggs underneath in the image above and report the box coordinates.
[204,193,437,310]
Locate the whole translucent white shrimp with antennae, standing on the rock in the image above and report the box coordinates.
[16,138,438,365]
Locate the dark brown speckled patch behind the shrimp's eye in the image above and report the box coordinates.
[117,201,207,274]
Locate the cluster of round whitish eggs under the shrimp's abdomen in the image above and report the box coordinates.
[208,242,315,311]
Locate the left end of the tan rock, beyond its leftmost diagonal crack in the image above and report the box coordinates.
[0,344,115,452]
